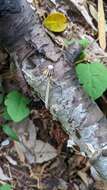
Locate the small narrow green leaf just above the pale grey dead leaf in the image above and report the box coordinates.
[2,124,19,141]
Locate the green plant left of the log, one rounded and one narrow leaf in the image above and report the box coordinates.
[1,90,30,141]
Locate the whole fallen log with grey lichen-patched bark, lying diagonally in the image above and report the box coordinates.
[0,0,107,180]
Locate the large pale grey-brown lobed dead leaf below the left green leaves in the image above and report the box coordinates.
[13,119,57,164]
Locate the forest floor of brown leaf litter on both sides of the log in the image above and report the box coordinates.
[0,0,107,190]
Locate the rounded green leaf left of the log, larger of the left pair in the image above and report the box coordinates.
[5,91,30,122]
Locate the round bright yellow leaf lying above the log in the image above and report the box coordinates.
[43,12,68,32]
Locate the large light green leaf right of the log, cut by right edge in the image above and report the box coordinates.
[76,62,107,100]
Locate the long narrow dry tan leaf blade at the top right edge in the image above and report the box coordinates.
[98,0,106,50]
